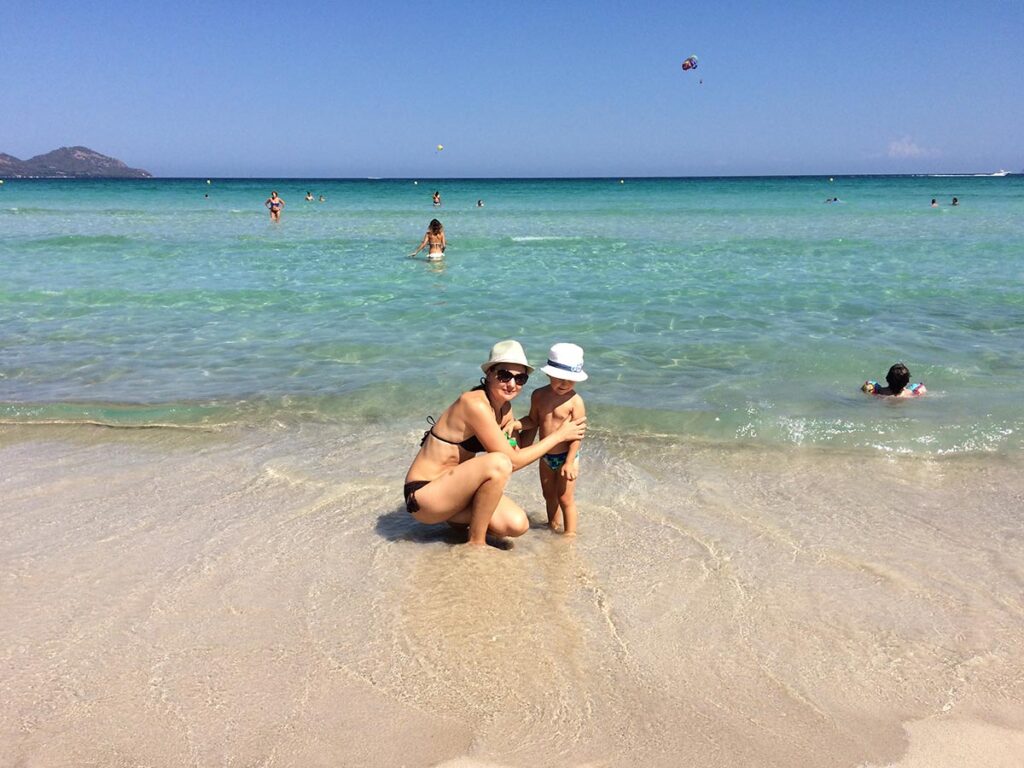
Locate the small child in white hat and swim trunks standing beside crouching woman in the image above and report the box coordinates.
[522,344,587,536]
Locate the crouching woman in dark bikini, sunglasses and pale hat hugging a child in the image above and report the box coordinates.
[404,341,587,546]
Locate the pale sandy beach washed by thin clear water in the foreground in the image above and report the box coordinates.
[0,425,1024,768]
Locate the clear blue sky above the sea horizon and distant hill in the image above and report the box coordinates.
[0,0,1024,177]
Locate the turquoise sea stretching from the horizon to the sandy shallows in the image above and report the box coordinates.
[0,176,1024,454]
